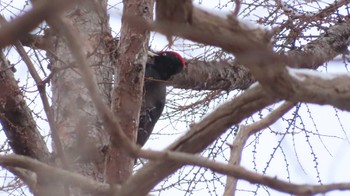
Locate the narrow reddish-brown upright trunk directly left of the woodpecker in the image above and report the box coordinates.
[106,0,153,183]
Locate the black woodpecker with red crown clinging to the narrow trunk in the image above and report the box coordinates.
[137,51,185,146]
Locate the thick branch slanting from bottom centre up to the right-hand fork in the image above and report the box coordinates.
[121,85,277,195]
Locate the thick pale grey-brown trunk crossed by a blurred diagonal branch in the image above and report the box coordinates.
[48,1,113,185]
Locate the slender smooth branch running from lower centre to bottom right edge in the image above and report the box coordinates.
[137,150,350,195]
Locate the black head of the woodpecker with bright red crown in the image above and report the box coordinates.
[149,51,185,80]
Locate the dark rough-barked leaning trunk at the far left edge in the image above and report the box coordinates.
[0,52,50,163]
